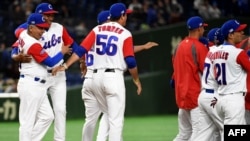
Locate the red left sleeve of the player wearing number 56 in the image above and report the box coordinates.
[80,30,96,51]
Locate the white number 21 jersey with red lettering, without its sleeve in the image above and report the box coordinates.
[212,44,247,94]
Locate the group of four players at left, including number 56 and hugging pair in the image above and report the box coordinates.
[11,3,158,141]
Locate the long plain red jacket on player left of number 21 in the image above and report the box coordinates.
[173,37,208,109]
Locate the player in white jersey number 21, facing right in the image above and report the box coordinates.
[214,20,250,129]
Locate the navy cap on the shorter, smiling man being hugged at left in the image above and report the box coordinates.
[27,13,49,28]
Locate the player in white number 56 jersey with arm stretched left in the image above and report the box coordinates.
[53,3,142,141]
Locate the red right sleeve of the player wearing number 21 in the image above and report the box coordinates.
[236,51,250,72]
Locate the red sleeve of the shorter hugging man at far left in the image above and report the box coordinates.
[28,43,49,63]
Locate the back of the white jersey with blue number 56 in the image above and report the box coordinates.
[93,22,133,71]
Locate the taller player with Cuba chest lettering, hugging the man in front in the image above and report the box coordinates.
[13,3,78,141]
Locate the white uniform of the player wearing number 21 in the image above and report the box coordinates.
[210,43,248,125]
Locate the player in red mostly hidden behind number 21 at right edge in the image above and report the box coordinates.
[236,37,250,125]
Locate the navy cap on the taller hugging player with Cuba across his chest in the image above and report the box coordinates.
[35,3,58,14]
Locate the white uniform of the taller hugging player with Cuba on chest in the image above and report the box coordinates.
[40,22,73,141]
